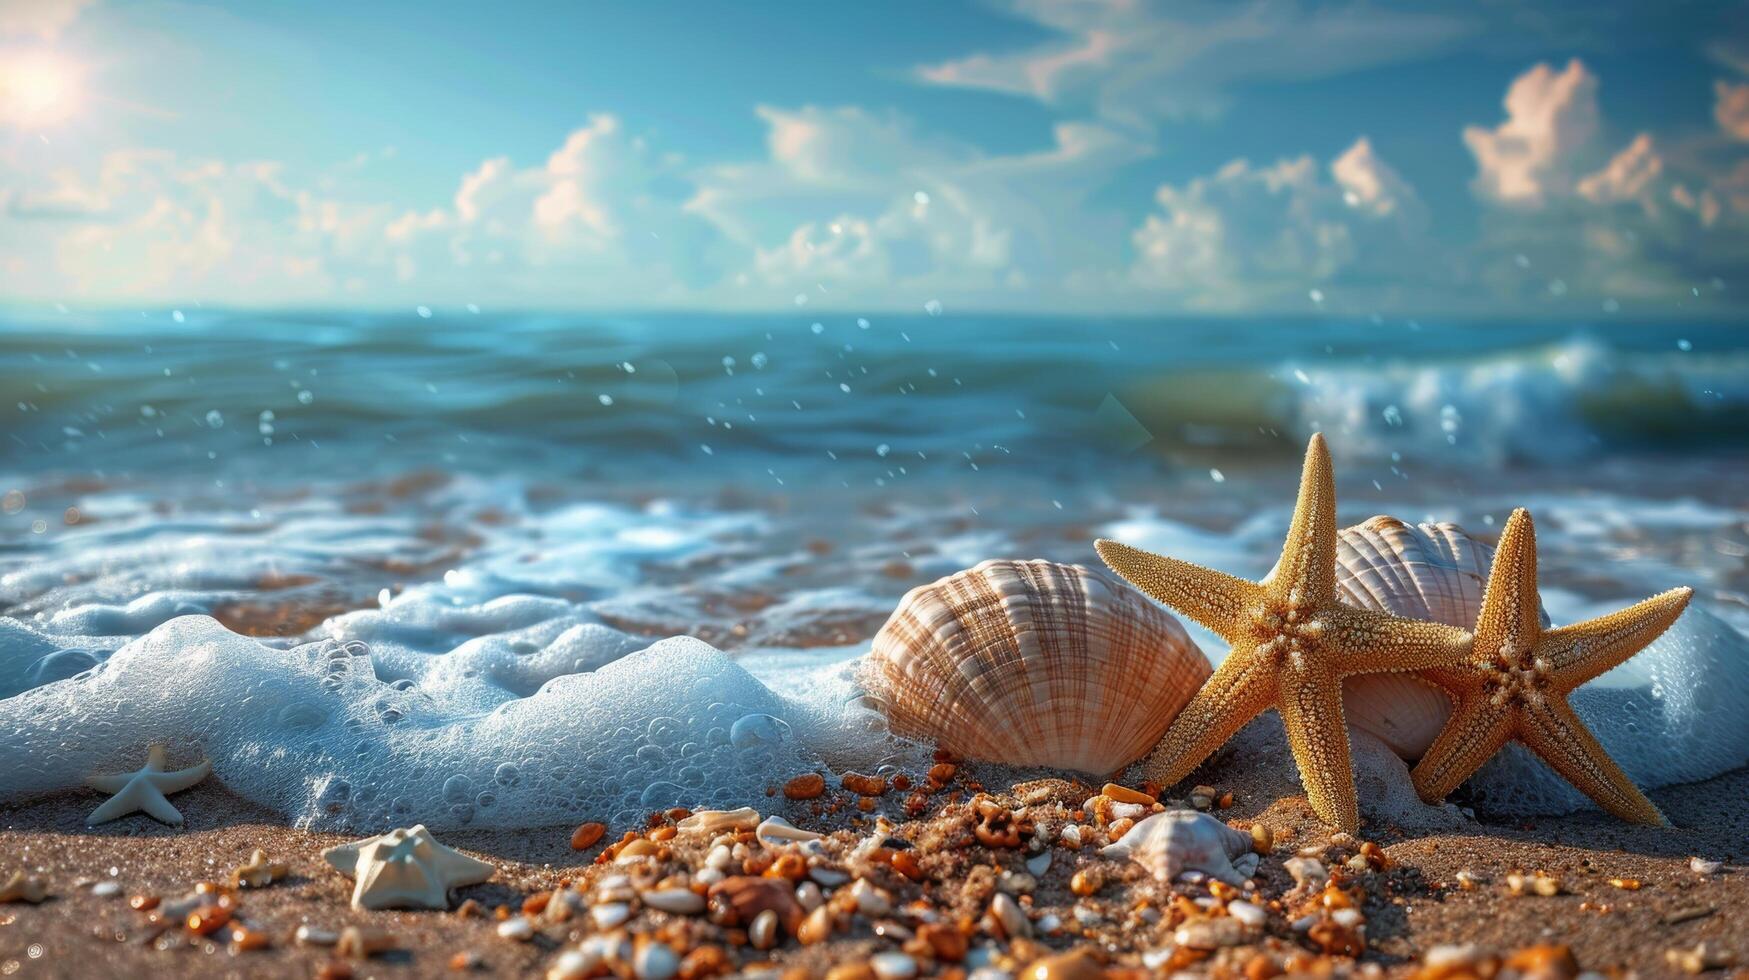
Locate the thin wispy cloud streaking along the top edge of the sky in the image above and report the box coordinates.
[916,0,1480,126]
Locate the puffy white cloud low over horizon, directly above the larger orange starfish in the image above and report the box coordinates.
[1132,138,1425,310]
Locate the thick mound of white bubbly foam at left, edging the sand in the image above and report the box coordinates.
[0,616,846,828]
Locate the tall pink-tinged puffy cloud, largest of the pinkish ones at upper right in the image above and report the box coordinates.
[1464,58,1599,208]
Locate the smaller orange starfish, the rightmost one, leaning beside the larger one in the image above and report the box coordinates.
[1411,509,1695,824]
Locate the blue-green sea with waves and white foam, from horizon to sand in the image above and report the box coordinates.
[0,310,1749,826]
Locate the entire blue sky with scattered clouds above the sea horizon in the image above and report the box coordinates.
[0,0,1749,317]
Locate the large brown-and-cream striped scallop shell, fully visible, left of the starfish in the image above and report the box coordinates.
[861,562,1210,775]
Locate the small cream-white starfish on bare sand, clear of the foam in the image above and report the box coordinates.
[322,824,495,908]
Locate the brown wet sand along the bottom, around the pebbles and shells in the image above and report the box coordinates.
[0,719,1749,977]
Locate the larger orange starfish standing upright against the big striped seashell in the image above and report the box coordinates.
[1095,436,1469,831]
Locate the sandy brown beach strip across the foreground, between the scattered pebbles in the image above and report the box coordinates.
[0,718,1749,977]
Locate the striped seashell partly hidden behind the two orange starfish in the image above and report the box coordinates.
[1336,516,1548,760]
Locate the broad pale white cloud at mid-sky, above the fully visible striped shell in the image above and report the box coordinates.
[693,107,1144,305]
